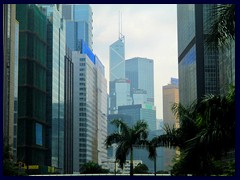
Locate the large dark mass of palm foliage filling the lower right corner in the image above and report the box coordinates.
[158,87,235,175]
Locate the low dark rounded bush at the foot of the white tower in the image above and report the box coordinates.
[79,161,109,174]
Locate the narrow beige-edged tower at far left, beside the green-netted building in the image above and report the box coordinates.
[3,4,19,161]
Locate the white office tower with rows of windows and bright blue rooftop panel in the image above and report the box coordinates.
[72,41,107,172]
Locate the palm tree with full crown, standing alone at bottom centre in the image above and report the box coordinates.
[105,119,148,176]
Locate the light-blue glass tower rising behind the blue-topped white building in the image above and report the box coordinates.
[63,4,93,51]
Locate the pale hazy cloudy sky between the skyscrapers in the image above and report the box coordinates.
[91,4,178,119]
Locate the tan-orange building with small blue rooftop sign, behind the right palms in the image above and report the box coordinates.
[162,79,179,127]
